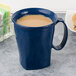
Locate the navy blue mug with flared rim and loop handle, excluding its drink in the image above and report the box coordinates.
[12,8,68,70]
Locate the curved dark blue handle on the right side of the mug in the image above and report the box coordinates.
[53,18,68,50]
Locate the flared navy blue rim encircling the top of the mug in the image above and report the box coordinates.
[11,8,58,29]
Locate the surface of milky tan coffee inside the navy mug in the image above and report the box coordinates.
[17,15,52,27]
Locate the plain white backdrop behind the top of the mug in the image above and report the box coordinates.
[0,0,76,12]
